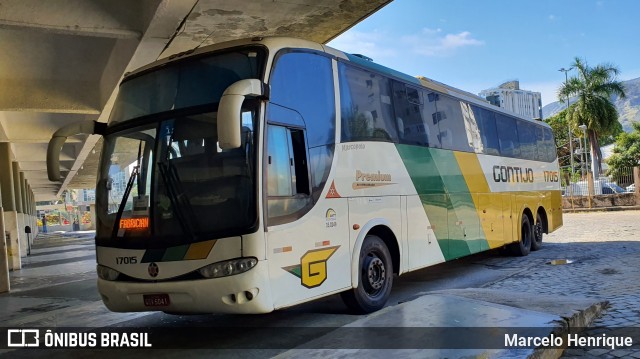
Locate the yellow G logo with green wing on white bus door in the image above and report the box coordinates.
[282,246,340,288]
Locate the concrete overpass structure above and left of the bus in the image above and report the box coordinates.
[0,0,391,291]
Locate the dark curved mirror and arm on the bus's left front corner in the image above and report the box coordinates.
[47,121,107,182]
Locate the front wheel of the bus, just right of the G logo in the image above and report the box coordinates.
[340,235,393,314]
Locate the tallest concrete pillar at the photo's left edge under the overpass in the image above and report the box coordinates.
[0,142,21,270]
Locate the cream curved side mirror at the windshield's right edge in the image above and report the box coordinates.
[218,79,267,149]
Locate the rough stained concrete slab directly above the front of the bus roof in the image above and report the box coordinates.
[161,0,391,58]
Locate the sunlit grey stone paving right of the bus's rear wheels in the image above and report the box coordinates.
[485,211,640,358]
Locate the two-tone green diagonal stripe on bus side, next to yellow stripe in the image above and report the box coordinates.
[396,144,489,260]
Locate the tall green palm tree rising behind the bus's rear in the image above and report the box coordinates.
[558,57,625,176]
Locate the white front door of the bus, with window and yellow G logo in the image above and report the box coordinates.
[264,124,351,309]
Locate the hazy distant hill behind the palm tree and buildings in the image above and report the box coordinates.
[542,77,640,132]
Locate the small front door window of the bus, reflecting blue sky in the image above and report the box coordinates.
[265,125,312,225]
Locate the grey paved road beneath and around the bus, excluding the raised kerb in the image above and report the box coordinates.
[0,211,640,358]
